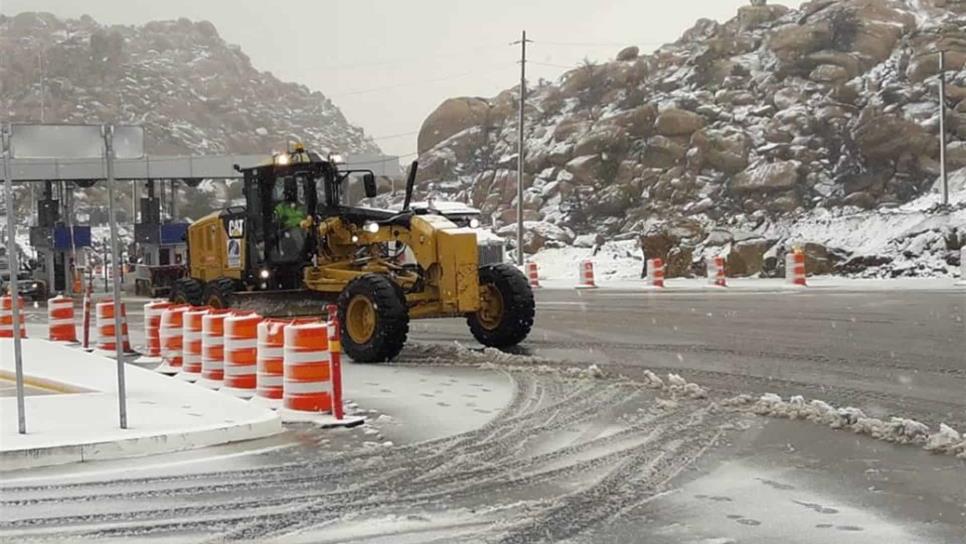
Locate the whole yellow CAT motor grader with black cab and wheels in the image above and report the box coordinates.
[171,147,534,362]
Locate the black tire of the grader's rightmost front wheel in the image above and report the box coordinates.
[466,263,536,348]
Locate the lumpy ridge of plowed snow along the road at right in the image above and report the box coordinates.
[721,393,966,459]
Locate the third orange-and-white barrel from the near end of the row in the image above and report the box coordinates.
[221,313,262,399]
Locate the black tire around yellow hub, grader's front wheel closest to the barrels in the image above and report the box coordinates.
[338,274,409,363]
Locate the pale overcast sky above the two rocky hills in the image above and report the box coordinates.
[0,0,800,155]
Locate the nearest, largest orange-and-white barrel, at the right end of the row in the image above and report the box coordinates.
[282,323,332,413]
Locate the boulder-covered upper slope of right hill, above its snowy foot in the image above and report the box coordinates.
[420,0,966,260]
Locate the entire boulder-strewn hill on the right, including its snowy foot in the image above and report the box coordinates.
[419,0,966,275]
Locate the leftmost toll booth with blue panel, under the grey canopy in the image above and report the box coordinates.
[23,181,91,300]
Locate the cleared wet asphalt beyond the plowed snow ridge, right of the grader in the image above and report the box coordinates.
[411,289,966,428]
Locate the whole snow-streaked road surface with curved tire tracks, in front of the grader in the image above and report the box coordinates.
[0,289,966,544]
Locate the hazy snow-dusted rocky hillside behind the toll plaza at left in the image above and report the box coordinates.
[0,12,378,155]
